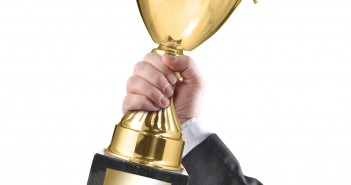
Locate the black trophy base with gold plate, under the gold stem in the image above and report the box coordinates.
[88,154,189,185]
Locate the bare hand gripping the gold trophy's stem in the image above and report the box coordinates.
[122,53,204,124]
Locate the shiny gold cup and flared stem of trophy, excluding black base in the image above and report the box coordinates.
[105,0,246,170]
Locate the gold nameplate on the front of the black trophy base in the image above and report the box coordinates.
[103,168,171,185]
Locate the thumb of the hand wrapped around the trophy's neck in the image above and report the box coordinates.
[162,55,202,80]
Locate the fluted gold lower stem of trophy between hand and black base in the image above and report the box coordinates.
[105,99,184,170]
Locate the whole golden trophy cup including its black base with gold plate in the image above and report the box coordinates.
[88,0,258,185]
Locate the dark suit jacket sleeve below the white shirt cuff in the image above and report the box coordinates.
[183,134,262,185]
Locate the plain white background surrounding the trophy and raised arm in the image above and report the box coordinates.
[0,0,351,185]
